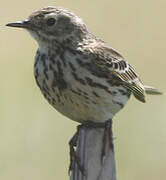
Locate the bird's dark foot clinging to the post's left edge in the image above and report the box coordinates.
[68,125,84,174]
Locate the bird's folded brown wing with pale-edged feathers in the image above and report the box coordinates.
[91,43,145,102]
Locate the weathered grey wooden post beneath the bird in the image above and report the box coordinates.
[70,119,116,180]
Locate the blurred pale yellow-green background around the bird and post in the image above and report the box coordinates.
[0,0,166,180]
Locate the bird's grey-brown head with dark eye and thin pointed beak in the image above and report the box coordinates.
[7,7,90,48]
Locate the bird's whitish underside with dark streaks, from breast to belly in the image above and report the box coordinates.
[34,50,130,122]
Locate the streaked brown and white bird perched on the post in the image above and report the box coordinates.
[7,6,162,173]
